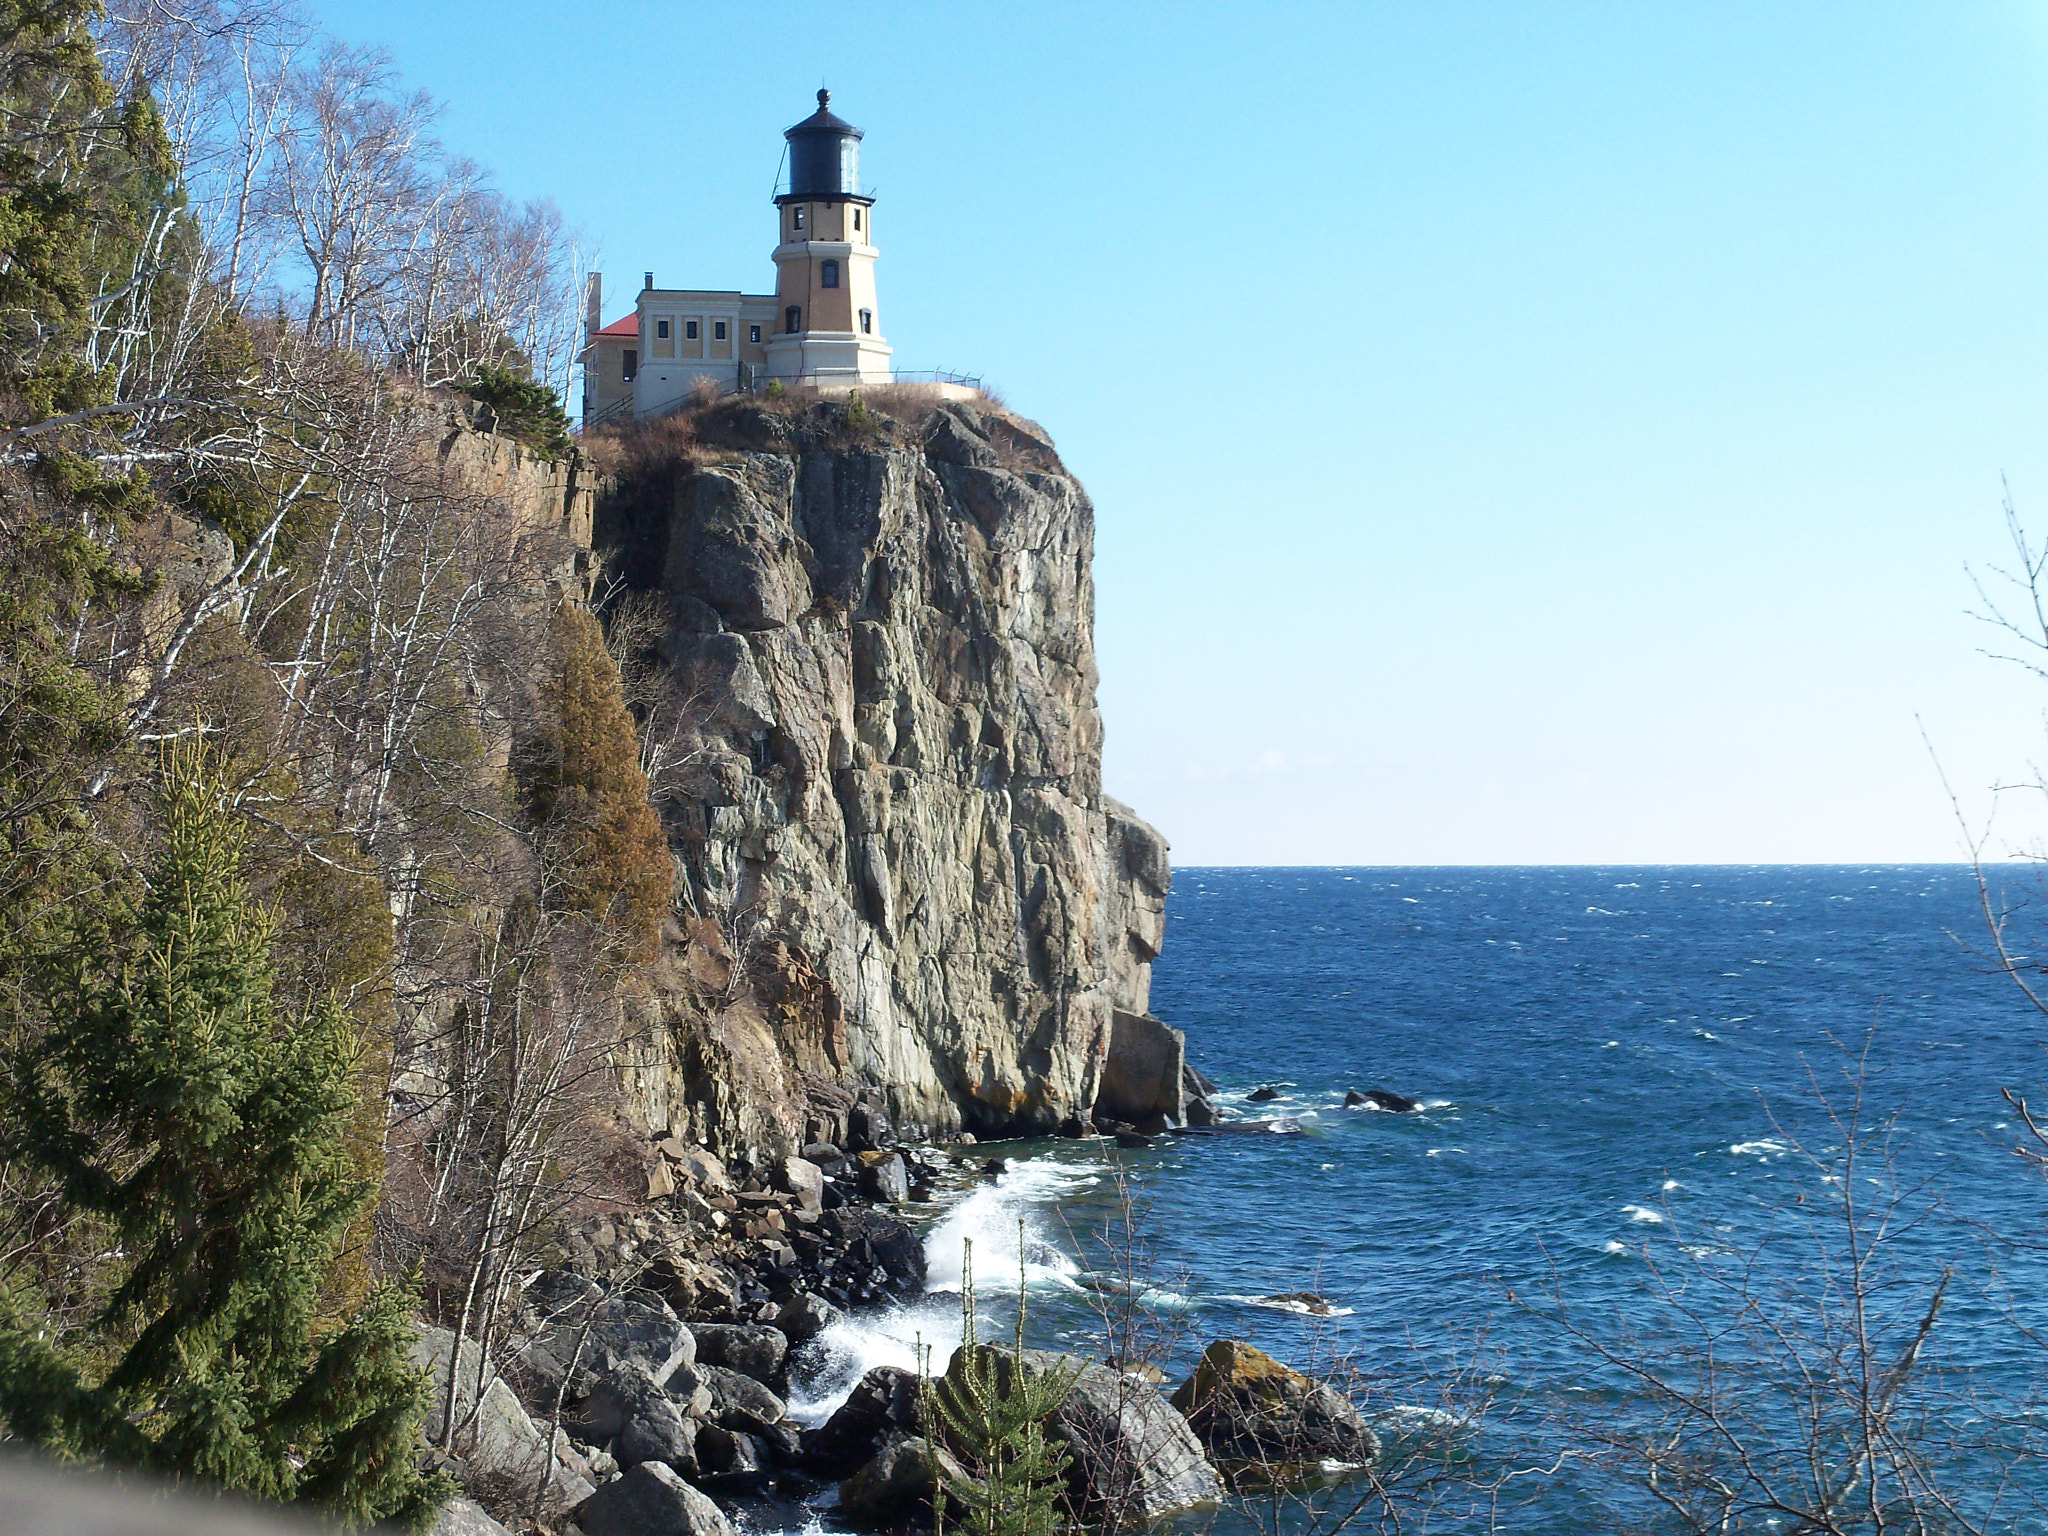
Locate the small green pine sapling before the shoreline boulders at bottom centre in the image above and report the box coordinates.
[922,1223,1073,1536]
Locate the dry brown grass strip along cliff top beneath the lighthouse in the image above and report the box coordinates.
[584,383,1063,475]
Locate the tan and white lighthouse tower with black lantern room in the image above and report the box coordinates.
[762,90,891,385]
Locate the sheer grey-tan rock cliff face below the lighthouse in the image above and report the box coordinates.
[594,403,1169,1151]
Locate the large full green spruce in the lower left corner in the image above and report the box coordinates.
[0,750,444,1524]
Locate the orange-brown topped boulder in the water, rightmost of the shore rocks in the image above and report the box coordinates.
[1174,1339,1380,1475]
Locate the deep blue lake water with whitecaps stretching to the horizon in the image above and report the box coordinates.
[790,866,2048,1532]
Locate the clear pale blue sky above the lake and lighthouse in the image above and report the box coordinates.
[322,0,2048,864]
